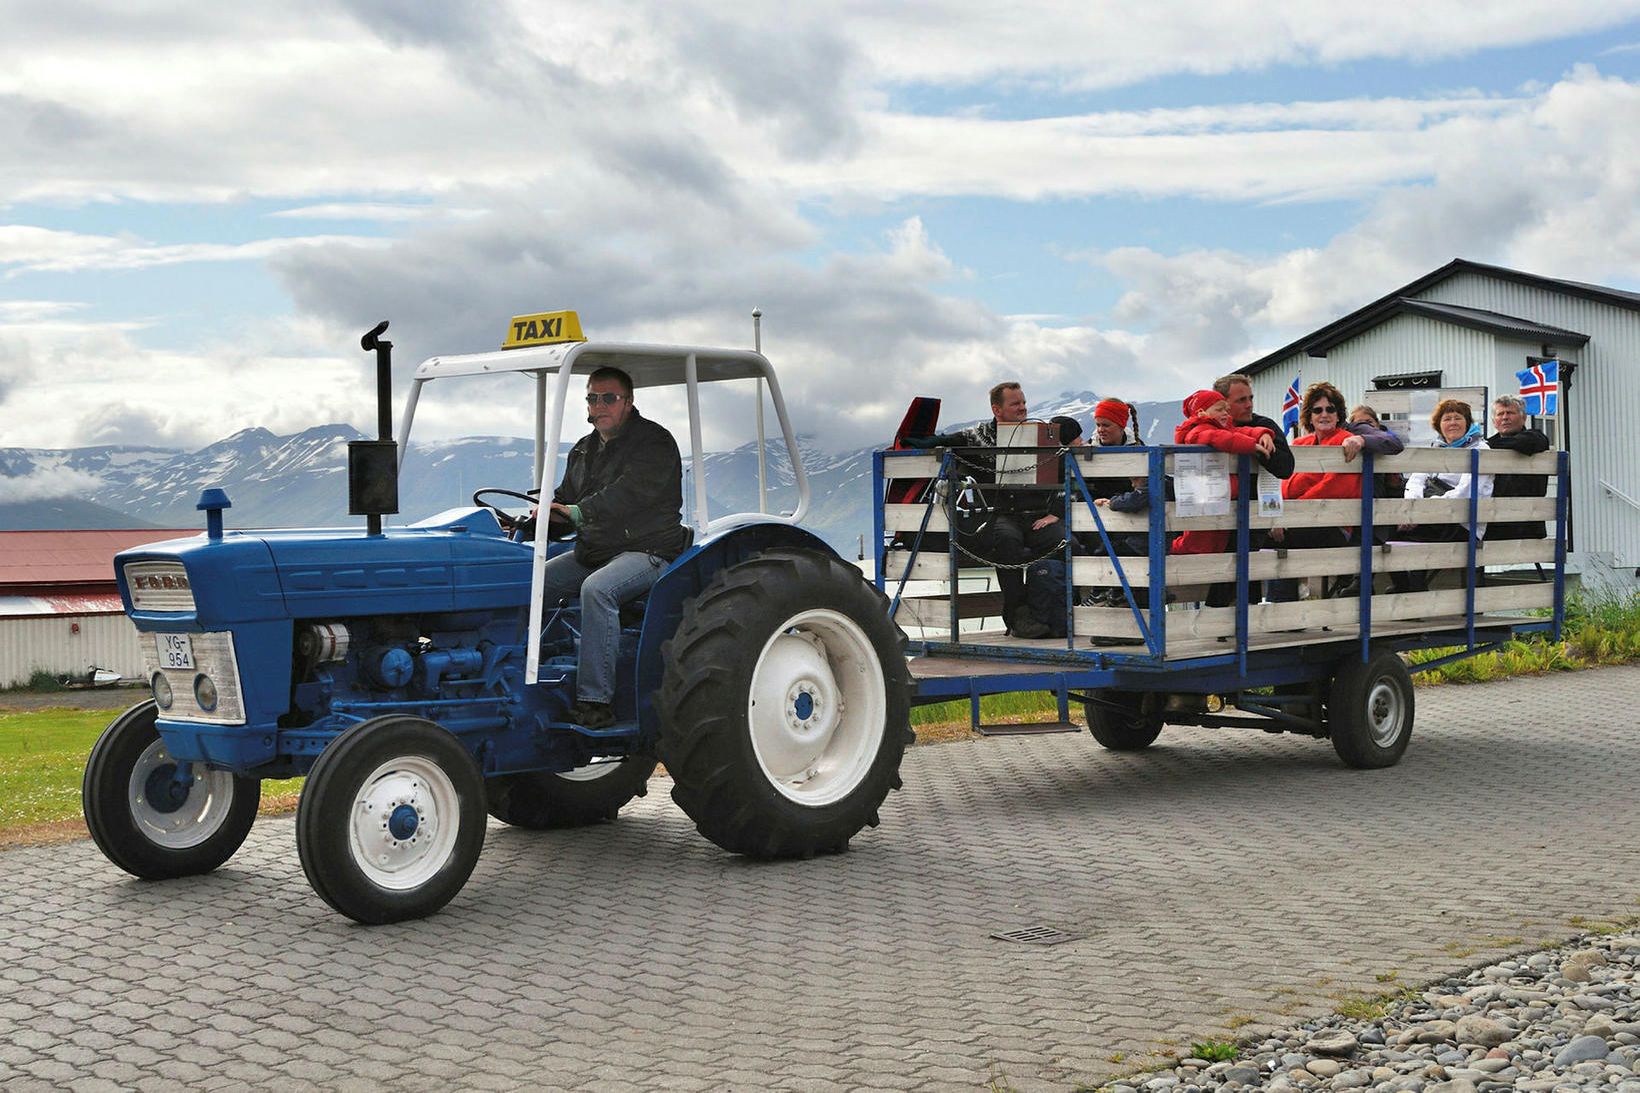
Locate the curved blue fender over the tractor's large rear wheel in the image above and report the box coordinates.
[636,522,841,747]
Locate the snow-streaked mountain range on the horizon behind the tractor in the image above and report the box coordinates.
[0,391,1179,556]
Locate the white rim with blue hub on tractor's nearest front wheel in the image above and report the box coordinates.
[348,755,461,891]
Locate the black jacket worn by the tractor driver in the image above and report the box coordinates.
[553,407,690,569]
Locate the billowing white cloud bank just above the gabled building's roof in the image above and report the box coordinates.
[1077,69,1640,371]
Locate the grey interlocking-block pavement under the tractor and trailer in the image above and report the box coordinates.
[0,668,1640,1093]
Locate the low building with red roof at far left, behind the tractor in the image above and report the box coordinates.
[0,528,198,686]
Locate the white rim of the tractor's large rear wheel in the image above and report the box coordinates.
[746,609,887,807]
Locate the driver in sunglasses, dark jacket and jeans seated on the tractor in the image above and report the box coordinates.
[544,368,689,729]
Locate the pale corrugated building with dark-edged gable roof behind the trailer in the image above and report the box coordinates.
[1241,258,1640,589]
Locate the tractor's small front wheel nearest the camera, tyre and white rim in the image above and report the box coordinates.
[297,716,484,924]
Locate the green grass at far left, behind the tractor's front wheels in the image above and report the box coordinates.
[0,709,302,832]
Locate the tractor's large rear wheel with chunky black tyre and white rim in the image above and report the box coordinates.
[656,550,912,858]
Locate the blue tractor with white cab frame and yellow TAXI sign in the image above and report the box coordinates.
[84,312,912,922]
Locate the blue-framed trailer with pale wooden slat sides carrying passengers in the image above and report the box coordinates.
[874,433,1569,768]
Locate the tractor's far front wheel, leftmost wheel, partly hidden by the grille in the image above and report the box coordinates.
[80,699,262,880]
